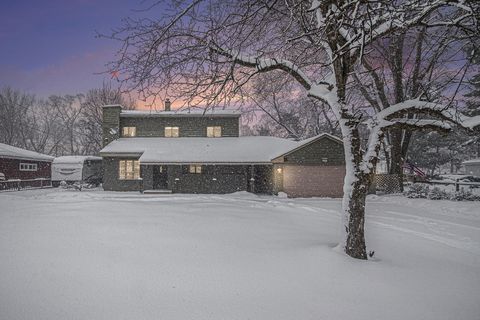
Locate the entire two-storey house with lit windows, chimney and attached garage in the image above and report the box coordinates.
[100,105,345,197]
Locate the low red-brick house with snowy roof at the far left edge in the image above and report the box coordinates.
[0,143,53,180]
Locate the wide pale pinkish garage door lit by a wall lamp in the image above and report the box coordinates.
[283,165,345,197]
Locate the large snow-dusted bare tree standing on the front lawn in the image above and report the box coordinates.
[111,0,480,259]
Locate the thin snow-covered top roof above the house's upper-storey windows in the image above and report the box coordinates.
[120,109,241,117]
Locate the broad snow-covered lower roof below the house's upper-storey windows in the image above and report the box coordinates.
[100,136,299,164]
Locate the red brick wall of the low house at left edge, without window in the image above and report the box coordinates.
[0,158,52,180]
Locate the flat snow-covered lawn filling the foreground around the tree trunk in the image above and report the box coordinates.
[0,189,480,320]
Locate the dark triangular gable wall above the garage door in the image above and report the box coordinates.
[284,137,345,166]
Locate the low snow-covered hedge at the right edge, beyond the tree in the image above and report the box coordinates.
[404,183,480,201]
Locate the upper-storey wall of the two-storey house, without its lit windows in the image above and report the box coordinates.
[120,116,239,137]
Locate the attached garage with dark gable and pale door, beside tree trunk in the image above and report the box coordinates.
[273,134,345,198]
